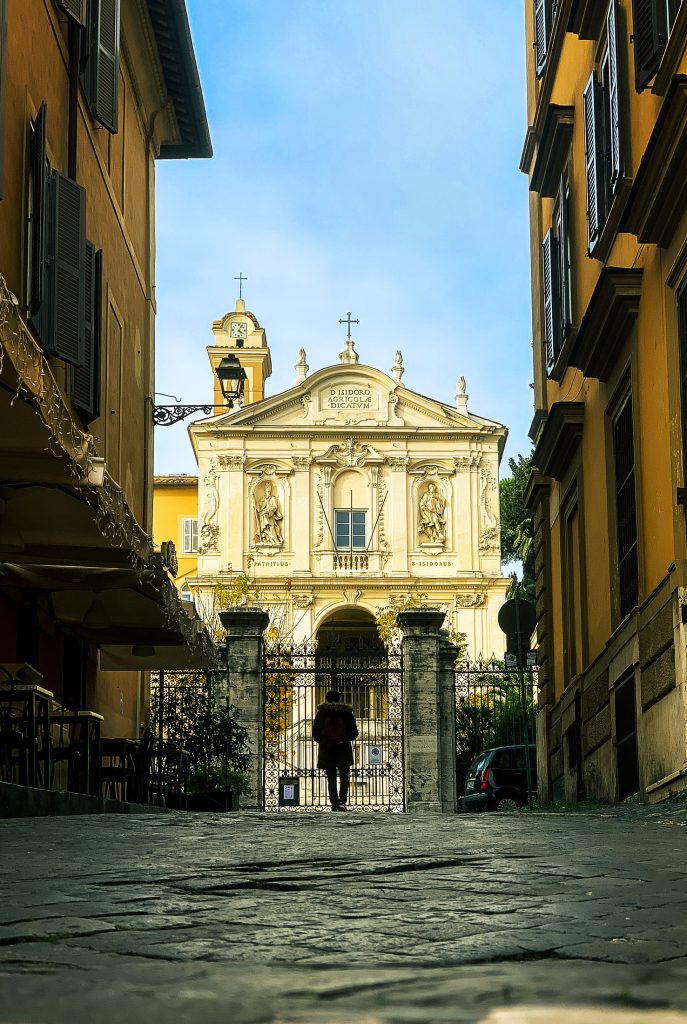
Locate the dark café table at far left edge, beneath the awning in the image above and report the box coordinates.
[0,680,54,790]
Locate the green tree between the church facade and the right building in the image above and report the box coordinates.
[499,453,534,602]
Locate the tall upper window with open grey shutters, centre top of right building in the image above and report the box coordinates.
[583,0,622,254]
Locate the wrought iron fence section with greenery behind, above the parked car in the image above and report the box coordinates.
[456,658,538,795]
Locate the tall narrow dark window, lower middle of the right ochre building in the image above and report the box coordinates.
[611,390,639,618]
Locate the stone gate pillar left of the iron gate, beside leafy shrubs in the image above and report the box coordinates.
[219,608,269,810]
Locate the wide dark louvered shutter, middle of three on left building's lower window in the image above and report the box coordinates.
[46,171,86,366]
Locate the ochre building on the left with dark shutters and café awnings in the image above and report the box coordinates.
[0,0,211,736]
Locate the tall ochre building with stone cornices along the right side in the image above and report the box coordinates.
[521,0,687,800]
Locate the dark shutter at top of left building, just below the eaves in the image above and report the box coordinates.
[84,0,120,132]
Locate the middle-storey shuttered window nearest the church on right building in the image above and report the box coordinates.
[542,170,572,372]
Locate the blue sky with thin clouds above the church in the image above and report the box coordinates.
[156,0,532,473]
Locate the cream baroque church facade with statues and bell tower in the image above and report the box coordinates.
[175,299,509,656]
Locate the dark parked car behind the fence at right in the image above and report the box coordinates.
[463,743,536,811]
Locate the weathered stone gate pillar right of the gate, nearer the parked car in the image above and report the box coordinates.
[398,608,456,813]
